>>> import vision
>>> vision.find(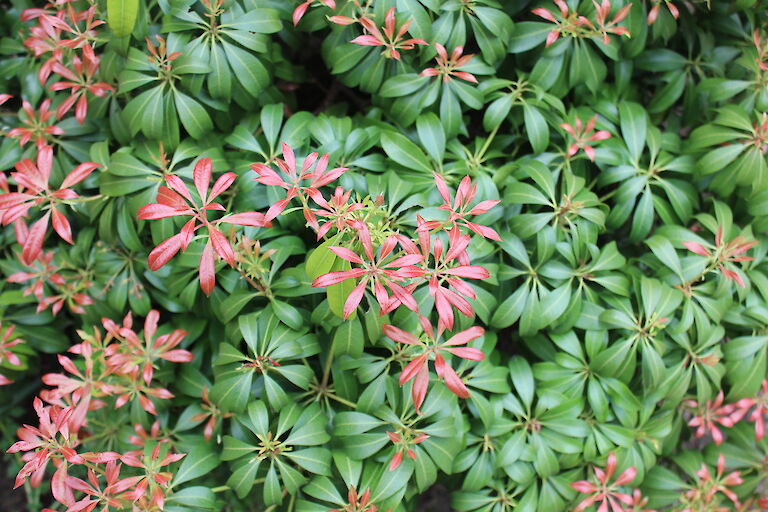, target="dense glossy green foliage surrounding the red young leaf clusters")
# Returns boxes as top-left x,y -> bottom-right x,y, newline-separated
0,0 -> 768,511
